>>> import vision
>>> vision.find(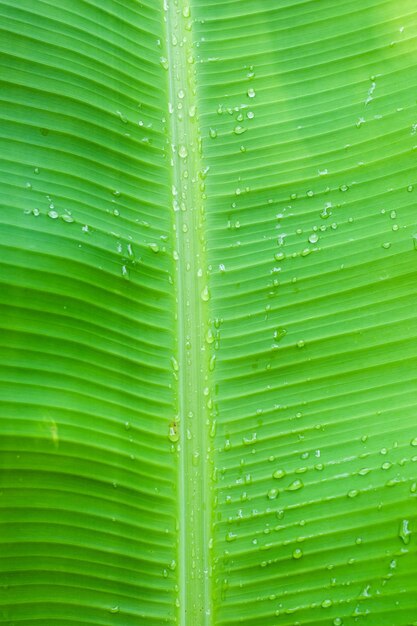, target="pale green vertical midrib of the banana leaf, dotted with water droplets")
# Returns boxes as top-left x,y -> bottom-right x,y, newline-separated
164,0 -> 213,626
